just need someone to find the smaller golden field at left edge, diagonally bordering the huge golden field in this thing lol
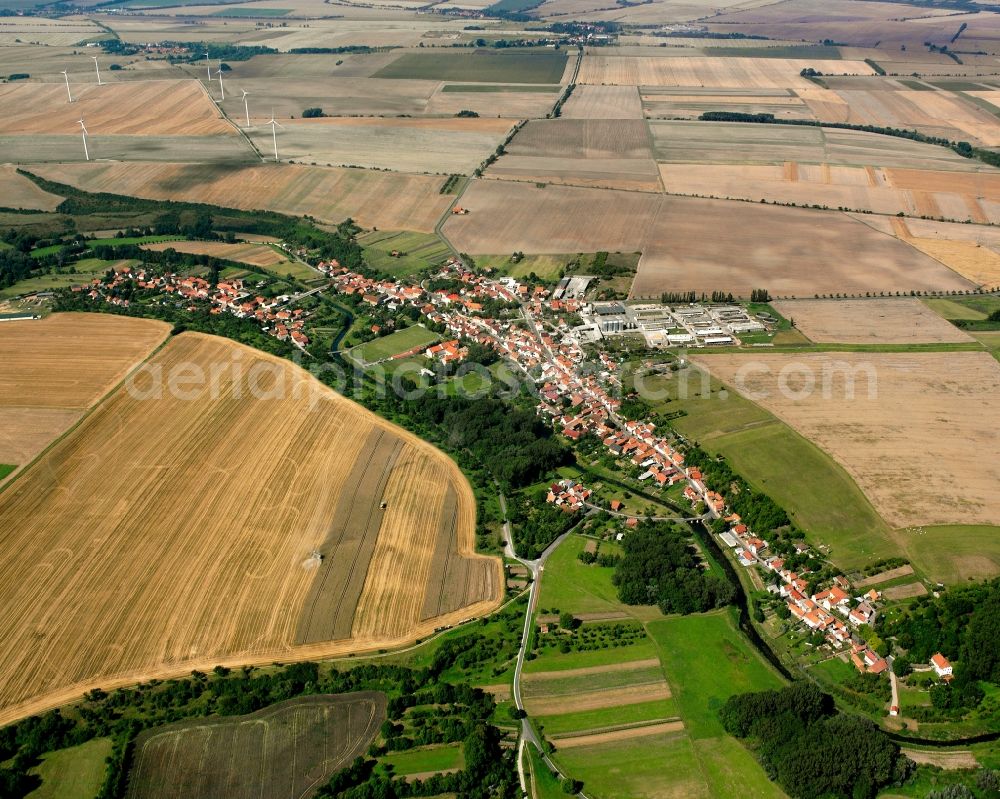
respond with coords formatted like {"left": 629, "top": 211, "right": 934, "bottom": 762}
{"left": 0, "top": 314, "right": 170, "bottom": 480}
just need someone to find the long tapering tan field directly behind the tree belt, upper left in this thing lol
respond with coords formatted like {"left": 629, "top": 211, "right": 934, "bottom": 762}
{"left": 31, "top": 162, "right": 454, "bottom": 231}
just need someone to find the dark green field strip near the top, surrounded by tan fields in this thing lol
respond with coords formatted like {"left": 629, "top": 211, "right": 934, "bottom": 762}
{"left": 372, "top": 49, "right": 566, "bottom": 84}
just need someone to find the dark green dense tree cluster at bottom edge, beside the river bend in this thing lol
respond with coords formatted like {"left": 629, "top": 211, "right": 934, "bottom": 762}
{"left": 719, "top": 682, "right": 913, "bottom": 799}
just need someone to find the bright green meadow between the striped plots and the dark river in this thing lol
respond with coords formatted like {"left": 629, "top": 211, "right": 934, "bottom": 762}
{"left": 646, "top": 610, "right": 782, "bottom": 738}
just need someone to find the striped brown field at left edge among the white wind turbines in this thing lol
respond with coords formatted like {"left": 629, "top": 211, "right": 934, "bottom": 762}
{"left": 0, "top": 80, "right": 237, "bottom": 136}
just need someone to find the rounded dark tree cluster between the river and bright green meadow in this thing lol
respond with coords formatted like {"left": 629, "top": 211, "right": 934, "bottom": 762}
{"left": 612, "top": 521, "right": 736, "bottom": 613}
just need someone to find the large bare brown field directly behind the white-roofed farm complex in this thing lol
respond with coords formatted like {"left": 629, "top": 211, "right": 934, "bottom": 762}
{"left": 632, "top": 197, "right": 973, "bottom": 298}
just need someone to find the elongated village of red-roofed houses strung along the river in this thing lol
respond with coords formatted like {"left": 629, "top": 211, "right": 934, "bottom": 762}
{"left": 75, "top": 253, "right": 951, "bottom": 715}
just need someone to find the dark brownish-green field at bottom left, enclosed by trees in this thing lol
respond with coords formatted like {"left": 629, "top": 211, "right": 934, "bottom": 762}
{"left": 126, "top": 692, "right": 386, "bottom": 799}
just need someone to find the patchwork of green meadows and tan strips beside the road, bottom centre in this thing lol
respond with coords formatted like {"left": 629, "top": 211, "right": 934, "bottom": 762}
{"left": 522, "top": 536, "right": 783, "bottom": 799}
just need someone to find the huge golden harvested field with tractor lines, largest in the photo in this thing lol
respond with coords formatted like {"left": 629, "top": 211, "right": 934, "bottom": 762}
{"left": 0, "top": 333, "right": 502, "bottom": 723}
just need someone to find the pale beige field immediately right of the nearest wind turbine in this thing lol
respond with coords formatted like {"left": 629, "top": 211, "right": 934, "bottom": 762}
{"left": 242, "top": 118, "right": 511, "bottom": 174}
